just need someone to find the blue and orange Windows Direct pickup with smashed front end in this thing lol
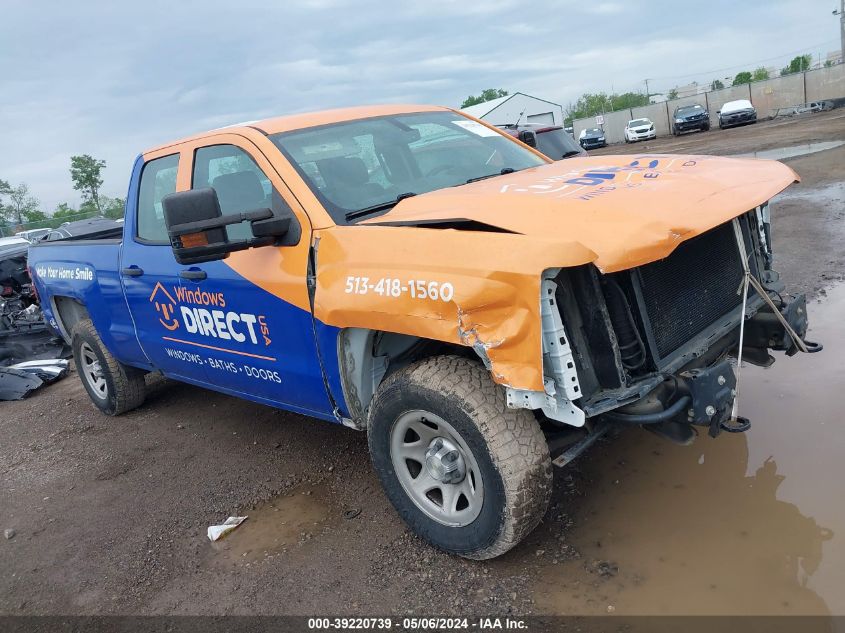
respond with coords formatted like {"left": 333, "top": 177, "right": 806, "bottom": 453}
{"left": 30, "top": 106, "right": 817, "bottom": 559}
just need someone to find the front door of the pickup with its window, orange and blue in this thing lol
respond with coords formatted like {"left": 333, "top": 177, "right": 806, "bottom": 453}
{"left": 179, "top": 135, "right": 333, "bottom": 417}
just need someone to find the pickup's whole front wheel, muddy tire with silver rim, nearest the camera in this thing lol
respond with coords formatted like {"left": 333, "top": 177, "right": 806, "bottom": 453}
{"left": 368, "top": 356, "right": 552, "bottom": 560}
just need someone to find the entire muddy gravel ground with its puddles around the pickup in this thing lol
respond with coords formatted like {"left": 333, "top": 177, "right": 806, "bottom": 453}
{"left": 0, "top": 110, "right": 845, "bottom": 615}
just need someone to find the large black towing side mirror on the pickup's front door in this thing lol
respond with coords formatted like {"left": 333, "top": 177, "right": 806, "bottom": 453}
{"left": 161, "top": 187, "right": 290, "bottom": 264}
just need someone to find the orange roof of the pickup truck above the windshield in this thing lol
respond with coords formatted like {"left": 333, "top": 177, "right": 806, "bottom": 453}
{"left": 143, "top": 104, "right": 451, "bottom": 154}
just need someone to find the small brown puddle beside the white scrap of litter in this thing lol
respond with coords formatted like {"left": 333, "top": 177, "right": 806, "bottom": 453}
{"left": 210, "top": 487, "right": 330, "bottom": 562}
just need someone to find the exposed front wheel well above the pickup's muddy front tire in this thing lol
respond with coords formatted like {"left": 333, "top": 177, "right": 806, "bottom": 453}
{"left": 338, "top": 328, "right": 468, "bottom": 429}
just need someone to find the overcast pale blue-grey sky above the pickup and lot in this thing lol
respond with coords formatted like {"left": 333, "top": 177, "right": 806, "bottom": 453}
{"left": 0, "top": 0, "right": 839, "bottom": 211}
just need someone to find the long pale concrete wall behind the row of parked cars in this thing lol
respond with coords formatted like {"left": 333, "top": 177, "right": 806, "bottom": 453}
{"left": 573, "top": 64, "right": 845, "bottom": 143}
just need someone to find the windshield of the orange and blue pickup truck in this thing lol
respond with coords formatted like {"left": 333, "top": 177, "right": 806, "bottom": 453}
{"left": 270, "top": 112, "right": 545, "bottom": 224}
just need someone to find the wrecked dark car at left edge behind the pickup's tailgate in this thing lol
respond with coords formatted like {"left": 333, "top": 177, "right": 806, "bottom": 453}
{"left": 0, "top": 237, "right": 68, "bottom": 400}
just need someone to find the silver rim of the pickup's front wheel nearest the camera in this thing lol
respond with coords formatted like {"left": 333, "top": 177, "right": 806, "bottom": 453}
{"left": 390, "top": 410, "right": 484, "bottom": 527}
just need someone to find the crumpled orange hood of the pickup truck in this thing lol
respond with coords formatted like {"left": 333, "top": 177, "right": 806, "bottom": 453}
{"left": 363, "top": 154, "right": 799, "bottom": 273}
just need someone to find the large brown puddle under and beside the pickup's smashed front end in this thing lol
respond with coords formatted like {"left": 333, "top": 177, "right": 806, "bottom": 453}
{"left": 535, "top": 286, "right": 845, "bottom": 615}
